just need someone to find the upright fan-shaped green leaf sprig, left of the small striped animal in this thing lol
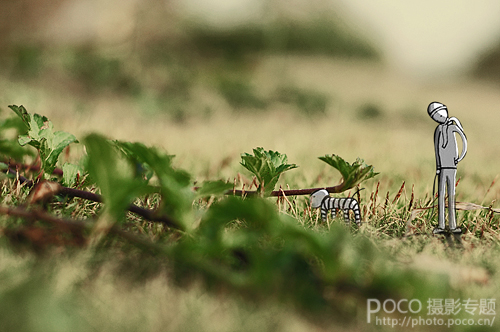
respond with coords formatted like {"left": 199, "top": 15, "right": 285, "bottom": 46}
{"left": 241, "top": 147, "right": 298, "bottom": 196}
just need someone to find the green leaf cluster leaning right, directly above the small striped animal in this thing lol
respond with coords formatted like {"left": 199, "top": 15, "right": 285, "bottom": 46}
{"left": 319, "top": 154, "right": 379, "bottom": 191}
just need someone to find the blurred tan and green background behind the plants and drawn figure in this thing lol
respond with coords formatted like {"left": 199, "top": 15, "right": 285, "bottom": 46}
{"left": 0, "top": 0, "right": 500, "bottom": 198}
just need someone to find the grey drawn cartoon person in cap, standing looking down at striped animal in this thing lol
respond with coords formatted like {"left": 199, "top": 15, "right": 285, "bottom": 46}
{"left": 427, "top": 102, "right": 467, "bottom": 234}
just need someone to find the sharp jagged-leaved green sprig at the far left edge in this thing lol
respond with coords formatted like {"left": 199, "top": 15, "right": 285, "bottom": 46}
{"left": 9, "top": 105, "right": 77, "bottom": 179}
